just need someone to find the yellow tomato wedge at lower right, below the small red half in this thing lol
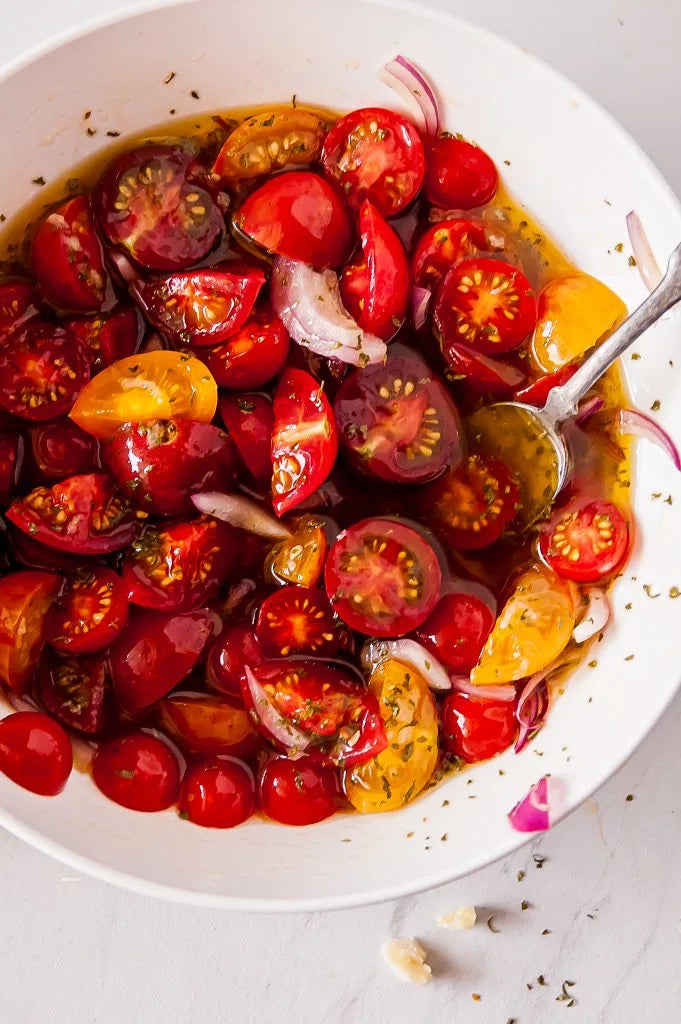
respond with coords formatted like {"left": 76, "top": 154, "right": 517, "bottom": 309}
{"left": 471, "top": 564, "right": 574, "bottom": 686}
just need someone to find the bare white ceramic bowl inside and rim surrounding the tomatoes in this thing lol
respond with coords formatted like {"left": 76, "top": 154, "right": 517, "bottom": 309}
{"left": 0, "top": 0, "right": 681, "bottom": 910}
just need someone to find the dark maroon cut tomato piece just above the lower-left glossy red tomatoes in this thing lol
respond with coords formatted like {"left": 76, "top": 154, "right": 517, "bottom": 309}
{"left": 37, "top": 652, "right": 111, "bottom": 736}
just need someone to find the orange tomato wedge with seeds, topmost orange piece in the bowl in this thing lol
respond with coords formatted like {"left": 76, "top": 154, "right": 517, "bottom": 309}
{"left": 211, "top": 106, "right": 327, "bottom": 181}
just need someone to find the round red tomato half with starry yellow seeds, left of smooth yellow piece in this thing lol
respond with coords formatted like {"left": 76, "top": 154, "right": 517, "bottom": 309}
{"left": 433, "top": 259, "right": 537, "bottom": 355}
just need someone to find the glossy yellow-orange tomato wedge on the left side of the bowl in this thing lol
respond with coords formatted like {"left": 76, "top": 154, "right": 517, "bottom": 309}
{"left": 69, "top": 352, "right": 217, "bottom": 439}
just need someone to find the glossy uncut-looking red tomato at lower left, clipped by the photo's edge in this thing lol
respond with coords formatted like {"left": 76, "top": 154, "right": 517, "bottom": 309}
{"left": 0, "top": 711, "right": 74, "bottom": 797}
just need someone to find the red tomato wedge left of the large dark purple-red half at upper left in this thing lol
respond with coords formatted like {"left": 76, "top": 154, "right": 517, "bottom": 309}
{"left": 31, "top": 196, "right": 109, "bottom": 313}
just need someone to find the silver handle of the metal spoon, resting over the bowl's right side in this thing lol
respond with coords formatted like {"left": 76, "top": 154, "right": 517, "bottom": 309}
{"left": 544, "top": 238, "right": 681, "bottom": 427}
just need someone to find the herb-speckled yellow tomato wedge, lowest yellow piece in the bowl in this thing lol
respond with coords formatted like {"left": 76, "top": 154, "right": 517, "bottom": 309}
{"left": 344, "top": 658, "right": 437, "bottom": 814}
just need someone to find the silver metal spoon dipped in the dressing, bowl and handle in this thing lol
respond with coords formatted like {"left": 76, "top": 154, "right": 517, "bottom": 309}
{"left": 468, "top": 244, "right": 681, "bottom": 526}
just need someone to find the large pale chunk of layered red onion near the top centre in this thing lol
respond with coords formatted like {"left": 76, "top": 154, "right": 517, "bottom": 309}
{"left": 270, "top": 256, "right": 386, "bottom": 367}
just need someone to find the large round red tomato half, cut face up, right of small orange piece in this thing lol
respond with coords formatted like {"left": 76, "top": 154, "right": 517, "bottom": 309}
{"left": 325, "top": 519, "right": 441, "bottom": 637}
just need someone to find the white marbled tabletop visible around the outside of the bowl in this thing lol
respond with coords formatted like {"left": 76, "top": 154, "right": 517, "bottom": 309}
{"left": 0, "top": 0, "right": 681, "bottom": 1024}
